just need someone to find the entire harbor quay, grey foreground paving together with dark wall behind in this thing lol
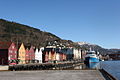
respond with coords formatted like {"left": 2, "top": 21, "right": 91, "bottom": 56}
{"left": 0, "top": 62, "right": 116, "bottom": 80}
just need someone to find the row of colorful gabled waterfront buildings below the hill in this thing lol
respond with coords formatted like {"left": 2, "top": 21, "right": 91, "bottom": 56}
{"left": 0, "top": 42, "right": 86, "bottom": 65}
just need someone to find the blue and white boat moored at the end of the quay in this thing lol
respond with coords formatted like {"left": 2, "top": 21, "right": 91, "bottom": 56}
{"left": 84, "top": 51, "right": 100, "bottom": 64}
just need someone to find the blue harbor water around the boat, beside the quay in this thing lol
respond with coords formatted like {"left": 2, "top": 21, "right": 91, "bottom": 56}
{"left": 74, "top": 61, "right": 120, "bottom": 80}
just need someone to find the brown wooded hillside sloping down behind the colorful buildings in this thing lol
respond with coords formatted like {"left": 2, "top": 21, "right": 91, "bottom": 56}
{"left": 0, "top": 19, "right": 73, "bottom": 47}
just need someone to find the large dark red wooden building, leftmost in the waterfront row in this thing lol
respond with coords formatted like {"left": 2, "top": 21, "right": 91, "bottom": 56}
{"left": 0, "top": 42, "right": 17, "bottom": 65}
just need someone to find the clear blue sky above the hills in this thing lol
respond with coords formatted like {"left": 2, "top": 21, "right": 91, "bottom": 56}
{"left": 0, "top": 0, "right": 120, "bottom": 48}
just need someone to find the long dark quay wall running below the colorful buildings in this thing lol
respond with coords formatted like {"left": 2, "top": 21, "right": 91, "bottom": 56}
{"left": 8, "top": 61, "right": 83, "bottom": 71}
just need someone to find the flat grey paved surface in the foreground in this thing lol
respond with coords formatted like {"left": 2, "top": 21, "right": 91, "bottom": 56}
{"left": 0, "top": 70, "right": 105, "bottom": 80}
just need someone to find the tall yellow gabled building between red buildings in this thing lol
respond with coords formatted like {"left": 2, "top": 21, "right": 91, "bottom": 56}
{"left": 18, "top": 43, "right": 26, "bottom": 64}
